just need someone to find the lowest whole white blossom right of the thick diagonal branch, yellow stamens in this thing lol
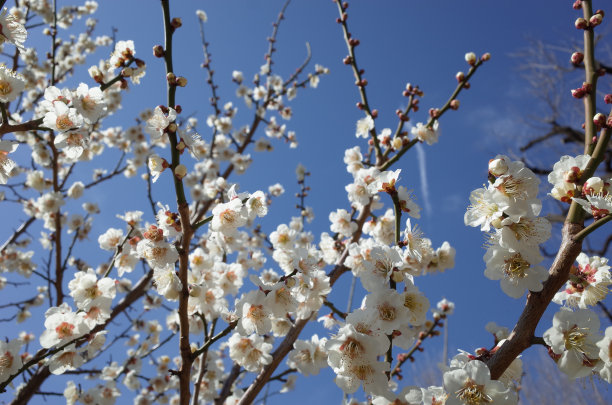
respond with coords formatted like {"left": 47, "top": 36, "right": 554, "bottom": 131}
{"left": 543, "top": 308, "right": 601, "bottom": 378}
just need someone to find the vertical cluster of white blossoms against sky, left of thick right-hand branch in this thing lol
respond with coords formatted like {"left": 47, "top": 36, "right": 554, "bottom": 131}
{"left": 464, "top": 156, "right": 551, "bottom": 298}
